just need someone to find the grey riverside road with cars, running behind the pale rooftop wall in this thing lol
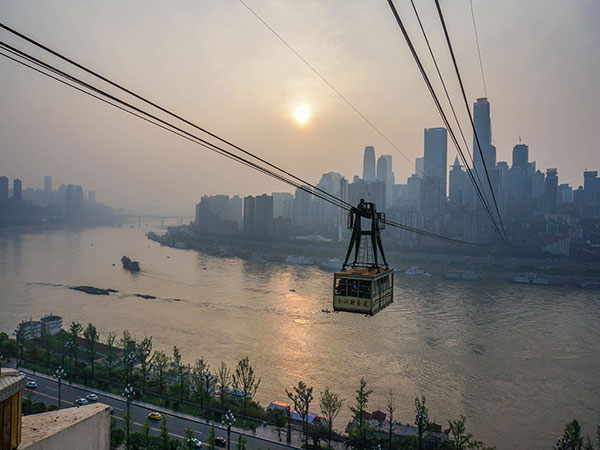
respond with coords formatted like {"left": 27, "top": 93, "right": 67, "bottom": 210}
{"left": 20, "top": 368, "right": 300, "bottom": 450}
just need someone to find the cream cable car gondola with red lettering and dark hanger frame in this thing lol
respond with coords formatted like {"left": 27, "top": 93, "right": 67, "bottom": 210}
{"left": 333, "top": 199, "right": 394, "bottom": 315}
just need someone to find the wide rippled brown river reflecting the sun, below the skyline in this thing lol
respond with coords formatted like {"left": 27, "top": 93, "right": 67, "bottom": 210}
{"left": 0, "top": 228, "right": 600, "bottom": 450}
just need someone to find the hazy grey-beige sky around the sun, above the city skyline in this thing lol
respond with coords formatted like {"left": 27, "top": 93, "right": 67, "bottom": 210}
{"left": 0, "top": 0, "right": 600, "bottom": 213}
